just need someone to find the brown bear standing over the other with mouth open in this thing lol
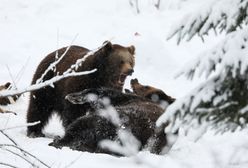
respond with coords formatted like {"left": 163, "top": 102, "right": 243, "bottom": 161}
{"left": 27, "top": 42, "right": 135, "bottom": 137}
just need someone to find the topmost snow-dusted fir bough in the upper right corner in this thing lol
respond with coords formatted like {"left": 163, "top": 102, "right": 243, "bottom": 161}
{"left": 167, "top": 0, "right": 248, "bottom": 44}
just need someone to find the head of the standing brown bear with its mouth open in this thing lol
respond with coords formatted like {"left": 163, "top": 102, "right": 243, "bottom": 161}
{"left": 96, "top": 41, "right": 135, "bottom": 90}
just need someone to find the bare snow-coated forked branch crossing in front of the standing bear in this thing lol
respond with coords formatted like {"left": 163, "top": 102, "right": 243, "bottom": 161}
{"left": 0, "top": 43, "right": 110, "bottom": 97}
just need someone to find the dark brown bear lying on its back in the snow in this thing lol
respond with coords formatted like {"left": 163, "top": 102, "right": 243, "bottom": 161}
{"left": 50, "top": 79, "right": 174, "bottom": 154}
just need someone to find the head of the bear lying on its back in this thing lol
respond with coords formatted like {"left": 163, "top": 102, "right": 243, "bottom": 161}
{"left": 130, "top": 79, "right": 175, "bottom": 104}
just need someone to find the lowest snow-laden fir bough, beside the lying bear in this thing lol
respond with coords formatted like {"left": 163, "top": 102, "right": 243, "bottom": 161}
{"left": 157, "top": 71, "right": 248, "bottom": 133}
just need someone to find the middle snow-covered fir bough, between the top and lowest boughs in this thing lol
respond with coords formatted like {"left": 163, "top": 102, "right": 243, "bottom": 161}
{"left": 177, "top": 26, "right": 248, "bottom": 79}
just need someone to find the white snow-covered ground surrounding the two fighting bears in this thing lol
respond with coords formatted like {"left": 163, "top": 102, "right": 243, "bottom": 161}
{"left": 0, "top": 0, "right": 248, "bottom": 168}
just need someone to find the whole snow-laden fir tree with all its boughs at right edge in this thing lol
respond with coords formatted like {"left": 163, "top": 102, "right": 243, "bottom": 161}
{"left": 157, "top": 0, "right": 248, "bottom": 132}
